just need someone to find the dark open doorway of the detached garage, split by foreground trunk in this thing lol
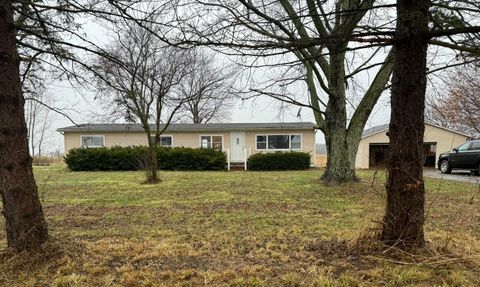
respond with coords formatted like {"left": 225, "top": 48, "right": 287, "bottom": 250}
{"left": 368, "top": 143, "right": 437, "bottom": 168}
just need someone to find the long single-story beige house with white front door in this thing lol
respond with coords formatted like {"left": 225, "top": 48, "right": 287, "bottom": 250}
{"left": 57, "top": 122, "right": 316, "bottom": 168}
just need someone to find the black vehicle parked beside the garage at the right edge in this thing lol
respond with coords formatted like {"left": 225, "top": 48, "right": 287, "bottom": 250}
{"left": 438, "top": 140, "right": 480, "bottom": 175}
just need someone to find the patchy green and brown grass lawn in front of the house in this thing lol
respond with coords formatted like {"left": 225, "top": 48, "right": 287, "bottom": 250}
{"left": 0, "top": 166, "right": 480, "bottom": 287}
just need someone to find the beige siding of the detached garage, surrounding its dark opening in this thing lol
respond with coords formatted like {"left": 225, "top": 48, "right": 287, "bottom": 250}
{"left": 355, "top": 124, "right": 467, "bottom": 168}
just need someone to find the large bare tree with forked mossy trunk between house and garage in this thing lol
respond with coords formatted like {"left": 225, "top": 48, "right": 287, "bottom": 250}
{"left": 167, "top": 0, "right": 392, "bottom": 183}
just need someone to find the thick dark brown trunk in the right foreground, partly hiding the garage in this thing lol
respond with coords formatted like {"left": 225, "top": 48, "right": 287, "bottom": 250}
{"left": 381, "top": 0, "right": 428, "bottom": 247}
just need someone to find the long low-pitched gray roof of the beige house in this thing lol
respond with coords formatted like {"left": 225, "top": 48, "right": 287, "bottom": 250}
{"left": 57, "top": 122, "right": 317, "bottom": 132}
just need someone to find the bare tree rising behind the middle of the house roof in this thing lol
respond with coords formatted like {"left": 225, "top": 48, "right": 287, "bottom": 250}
{"left": 179, "top": 48, "right": 236, "bottom": 124}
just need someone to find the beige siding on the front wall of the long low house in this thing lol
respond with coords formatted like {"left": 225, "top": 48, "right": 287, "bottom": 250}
{"left": 64, "top": 129, "right": 315, "bottom": 164}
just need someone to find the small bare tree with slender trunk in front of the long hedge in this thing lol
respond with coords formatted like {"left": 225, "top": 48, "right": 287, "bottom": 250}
{"left": 96, "top": 21, "right": 190, "bottom": 183}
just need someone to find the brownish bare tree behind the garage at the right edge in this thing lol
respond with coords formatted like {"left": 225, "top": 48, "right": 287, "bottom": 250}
{"left": 425, "top": 64, "right": 480, "bottom": 138}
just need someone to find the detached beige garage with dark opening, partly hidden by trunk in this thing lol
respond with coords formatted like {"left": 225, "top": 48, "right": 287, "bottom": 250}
{"left": 356, "top": 123, "right": 469, "bottom": 168}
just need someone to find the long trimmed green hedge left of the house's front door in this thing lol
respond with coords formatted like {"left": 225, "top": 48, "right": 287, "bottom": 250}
{"left": 64, "top": 146, "right": 227, "bottom": 171}
